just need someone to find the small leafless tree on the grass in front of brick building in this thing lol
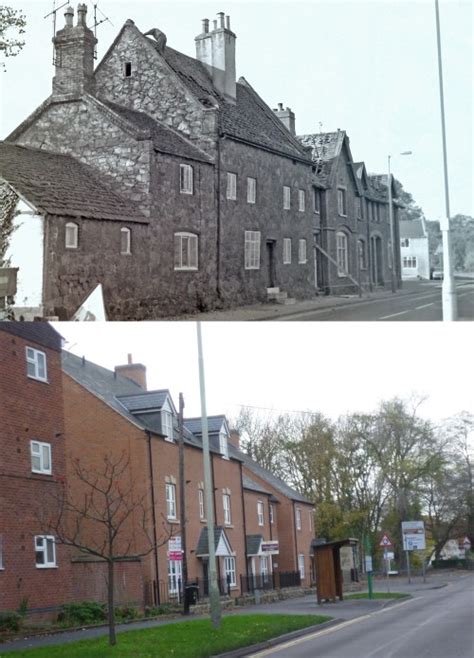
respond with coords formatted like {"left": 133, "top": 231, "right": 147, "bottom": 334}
{"left": 39, "top": 453, "right": 172, "bottom": 645}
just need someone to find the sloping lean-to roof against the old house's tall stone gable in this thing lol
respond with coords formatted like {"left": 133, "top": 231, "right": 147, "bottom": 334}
{"left": 102, "top": 101, "right": 211, "bottom": 162}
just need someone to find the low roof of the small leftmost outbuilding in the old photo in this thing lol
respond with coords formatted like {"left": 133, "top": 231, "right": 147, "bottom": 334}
{"left": 0, "top": 142, "right": 148, "bottom": 223}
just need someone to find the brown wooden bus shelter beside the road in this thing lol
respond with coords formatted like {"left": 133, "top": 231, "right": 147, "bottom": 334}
{"left": 313, "top": 538, "right": 358, "bottom": 603}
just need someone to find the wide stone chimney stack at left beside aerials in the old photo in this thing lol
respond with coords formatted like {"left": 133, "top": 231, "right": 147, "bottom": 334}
{"left": 53, "top": 4, "right": 97, "bottom": 96}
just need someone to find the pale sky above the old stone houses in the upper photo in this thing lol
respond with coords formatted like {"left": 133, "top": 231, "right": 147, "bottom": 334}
{"left": 0, "top": 0, "right": 474, "bottom": 220}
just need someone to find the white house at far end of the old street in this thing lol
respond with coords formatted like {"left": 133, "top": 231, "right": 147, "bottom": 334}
{"left": 400, "top": 218, "right": 430, "bottom": 279}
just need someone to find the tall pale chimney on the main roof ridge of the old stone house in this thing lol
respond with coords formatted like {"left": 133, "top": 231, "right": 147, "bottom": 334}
{"left": 195, "top": 12, "right": 237, "bottom": 102}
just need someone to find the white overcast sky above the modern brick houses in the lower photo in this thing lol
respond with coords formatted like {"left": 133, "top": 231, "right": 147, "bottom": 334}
{"left": 54, "top": 322, "right": 474, "bottom": 421}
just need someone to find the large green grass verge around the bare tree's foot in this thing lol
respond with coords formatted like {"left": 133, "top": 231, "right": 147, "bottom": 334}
{"left": 1, "top": 615, "right": 331, "bottom": 658}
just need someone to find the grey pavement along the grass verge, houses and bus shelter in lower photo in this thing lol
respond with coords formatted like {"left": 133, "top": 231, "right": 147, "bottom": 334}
{"left": 0, "top": 571, "right": 472, "bottom": 657}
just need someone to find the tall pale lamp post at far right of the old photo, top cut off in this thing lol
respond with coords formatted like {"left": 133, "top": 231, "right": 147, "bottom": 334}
{"left": 435, "top": 0, "right": 458, "bottom": 322}
